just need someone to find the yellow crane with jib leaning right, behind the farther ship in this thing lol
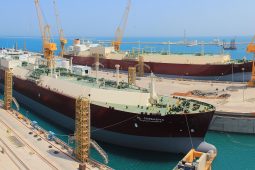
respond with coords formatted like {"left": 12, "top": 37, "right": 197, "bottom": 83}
{"left": 112, "top": 0, "right": 131, "bottom": 51}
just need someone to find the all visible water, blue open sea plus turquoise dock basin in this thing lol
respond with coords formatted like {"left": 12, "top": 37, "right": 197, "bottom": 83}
{"left": 0, "top": 37, "right": 255, "bottom": 170}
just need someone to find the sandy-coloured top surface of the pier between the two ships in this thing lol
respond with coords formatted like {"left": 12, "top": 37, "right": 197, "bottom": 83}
{"left": 92, "top": 71, "right": 255, "bottom": 113}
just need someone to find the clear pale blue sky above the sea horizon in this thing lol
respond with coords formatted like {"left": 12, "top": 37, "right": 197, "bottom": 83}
{"left": 0, "top": 0, "right": 255, "bottom": 37}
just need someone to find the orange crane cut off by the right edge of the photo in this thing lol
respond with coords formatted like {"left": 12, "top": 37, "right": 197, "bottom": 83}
{"left": 246, "top": 36, "right": 255, "bottom": 87}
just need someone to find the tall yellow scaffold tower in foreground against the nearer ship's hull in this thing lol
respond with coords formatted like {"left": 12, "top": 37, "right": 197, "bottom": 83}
{"left": 75, "top": 97, "right": 90, "bottom": 163}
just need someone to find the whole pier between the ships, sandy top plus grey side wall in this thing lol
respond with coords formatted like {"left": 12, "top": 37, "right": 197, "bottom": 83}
{"left": 92, "top": 71, "right": 255, "bottom": 134}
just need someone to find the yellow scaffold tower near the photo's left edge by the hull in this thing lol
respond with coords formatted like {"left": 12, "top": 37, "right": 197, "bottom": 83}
{"left": 4, "top": 69, "right": 12, "bottom": 110}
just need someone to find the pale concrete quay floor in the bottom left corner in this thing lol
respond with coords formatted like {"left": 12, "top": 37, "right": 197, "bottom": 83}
{"left": 0, "top": 105, "right": 112, "bottom": 170}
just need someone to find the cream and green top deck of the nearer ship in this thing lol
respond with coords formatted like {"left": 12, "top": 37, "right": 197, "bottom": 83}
{"left": 11, "top": 66, "right": 214, "bottom": 116}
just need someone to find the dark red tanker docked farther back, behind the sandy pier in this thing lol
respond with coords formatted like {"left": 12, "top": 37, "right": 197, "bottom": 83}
{"left": 64, "top": 39, "right": 252, "bottom": 77}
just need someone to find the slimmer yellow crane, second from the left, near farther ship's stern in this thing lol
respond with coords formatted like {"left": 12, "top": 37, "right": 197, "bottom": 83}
{"left": 53, "top": 0, "right": 67, "bottom": 57}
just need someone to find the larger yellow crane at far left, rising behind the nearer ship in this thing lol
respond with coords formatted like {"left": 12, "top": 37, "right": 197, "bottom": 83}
{"left": 34, "top": 0, "right": 57, "bottom": 68}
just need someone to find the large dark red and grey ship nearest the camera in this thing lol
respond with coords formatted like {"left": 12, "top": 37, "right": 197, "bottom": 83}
{"left": 0, "top": 48, "right": 216, "bottom": 153}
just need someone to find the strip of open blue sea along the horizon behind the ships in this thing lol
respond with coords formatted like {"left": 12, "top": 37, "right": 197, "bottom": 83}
{"left": 0, "top": 36, "right": 252, "bottom": 59}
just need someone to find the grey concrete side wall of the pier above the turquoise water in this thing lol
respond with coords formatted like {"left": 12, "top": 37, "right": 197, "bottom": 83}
{"left": 209, "top": 112, "right": 255, "bottom": 134}
